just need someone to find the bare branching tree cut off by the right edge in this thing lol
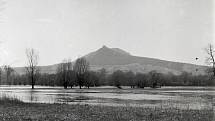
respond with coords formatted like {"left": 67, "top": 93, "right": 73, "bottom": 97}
{"left": 205, "top": 44, "right": 215, "bottom": 76}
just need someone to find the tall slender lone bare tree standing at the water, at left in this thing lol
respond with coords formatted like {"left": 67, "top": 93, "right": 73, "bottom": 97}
{"left": 26, "top": 48, "right": 39, "bottom": 89}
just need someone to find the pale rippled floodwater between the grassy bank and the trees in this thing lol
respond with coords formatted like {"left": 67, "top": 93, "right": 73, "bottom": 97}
{"left": 0, "top": 85, "right": 215, "bottom": 109}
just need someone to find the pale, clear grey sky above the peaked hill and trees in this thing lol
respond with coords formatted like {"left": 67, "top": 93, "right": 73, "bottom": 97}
{"left": 0, "top": 0, "right": 215, "bottom": 66}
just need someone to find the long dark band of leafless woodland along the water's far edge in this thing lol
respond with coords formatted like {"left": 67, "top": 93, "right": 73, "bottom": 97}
{"left": 0, "top": 58, "right": 215, "bottom": 89}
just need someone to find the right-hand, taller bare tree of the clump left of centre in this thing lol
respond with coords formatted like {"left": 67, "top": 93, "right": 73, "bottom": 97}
{"left": 74, "top": 57, "right": 89, "bottom": 89}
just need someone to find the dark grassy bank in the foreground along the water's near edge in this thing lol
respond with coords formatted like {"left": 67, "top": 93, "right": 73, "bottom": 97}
{"left": 0, "top": 98, "right": 214, "bottom": 121}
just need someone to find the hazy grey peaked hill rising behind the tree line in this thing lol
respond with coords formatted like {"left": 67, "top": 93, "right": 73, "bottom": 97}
{"left": 15, "top": 46, "right": 207, "bottom": 75}
